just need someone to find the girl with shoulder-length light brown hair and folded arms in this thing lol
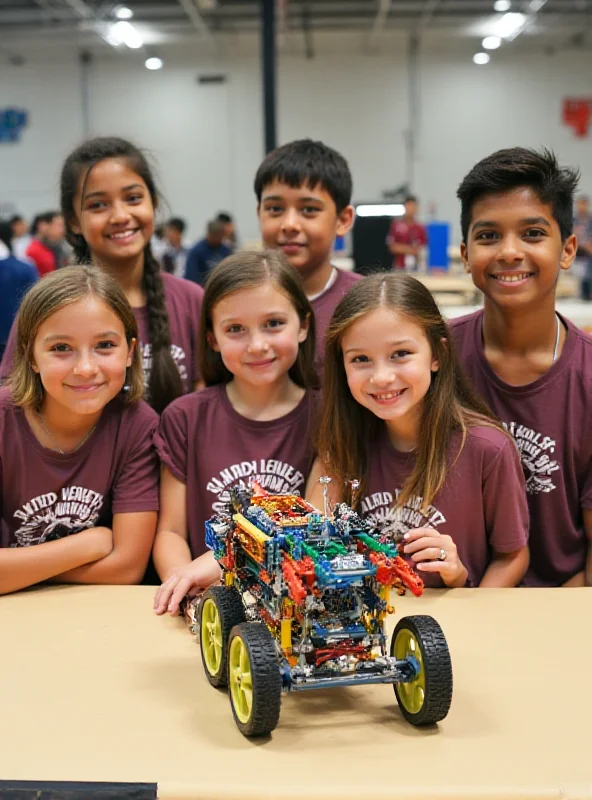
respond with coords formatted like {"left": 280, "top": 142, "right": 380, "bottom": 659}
{"left": 0, "top": 267, "right": 158, "bottom": 594}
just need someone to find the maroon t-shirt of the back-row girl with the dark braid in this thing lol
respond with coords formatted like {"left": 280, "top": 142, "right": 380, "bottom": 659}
{"left": 0, "top": 272, "right": 203, "bottom": 392}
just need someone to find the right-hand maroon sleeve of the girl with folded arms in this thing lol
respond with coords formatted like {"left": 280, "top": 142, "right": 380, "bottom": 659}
{"left": 112, "top": 408, "right": 160, "bottom": 514}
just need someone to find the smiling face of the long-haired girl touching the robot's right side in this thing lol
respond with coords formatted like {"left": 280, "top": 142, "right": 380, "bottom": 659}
{"left": 341, "top": 306, "right": 438, "bottom": 444}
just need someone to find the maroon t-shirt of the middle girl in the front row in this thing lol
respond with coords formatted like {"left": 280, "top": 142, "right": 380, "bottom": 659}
{"left": 155, "top": 384, "right": 318, "bottom": 558}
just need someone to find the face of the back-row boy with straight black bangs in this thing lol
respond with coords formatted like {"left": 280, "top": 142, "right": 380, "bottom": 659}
{"left": 257, "top": 180, "right": 353, "bottom": 277}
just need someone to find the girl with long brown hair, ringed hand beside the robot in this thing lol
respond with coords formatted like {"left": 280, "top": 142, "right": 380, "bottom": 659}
{"left": 307, "top": 274, "right": 528, "bottom": 587}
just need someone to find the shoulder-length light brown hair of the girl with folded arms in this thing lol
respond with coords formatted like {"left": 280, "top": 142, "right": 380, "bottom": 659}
{"left": 9, "top": 267, "right": 144, "bottom": 410}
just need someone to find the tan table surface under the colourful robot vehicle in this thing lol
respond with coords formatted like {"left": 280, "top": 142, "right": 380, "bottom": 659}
{"left": 0, "top": 586, "right": 592, "bottom": 800}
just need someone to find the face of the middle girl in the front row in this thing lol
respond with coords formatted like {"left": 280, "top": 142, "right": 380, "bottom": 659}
{"left": 210, "top": 282, "right": 308, "bottom": 386}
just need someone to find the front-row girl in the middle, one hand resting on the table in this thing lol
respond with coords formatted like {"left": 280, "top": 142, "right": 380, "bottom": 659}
{"left": 153, "top": 251, "right": 318, "bottom": 614}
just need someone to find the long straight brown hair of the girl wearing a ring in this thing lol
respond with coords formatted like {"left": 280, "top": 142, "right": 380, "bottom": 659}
{"left": 318, "top": 274, "right": 503, "bottom": 509}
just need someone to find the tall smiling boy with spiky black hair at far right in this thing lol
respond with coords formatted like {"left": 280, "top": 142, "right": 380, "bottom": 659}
{"left": 451, "top": 148, "right": 592, "bottom": 586}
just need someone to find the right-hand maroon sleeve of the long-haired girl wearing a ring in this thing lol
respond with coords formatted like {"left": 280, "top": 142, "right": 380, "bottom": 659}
{"left": 483, "top": 437, "right": 529, "bottom": 553}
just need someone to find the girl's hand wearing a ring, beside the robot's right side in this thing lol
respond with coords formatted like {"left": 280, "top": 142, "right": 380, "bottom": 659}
{"left": 403, "top": 528, "right": 468, "bottom": 586}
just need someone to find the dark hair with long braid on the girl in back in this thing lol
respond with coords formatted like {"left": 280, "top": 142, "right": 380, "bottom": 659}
{"left": 60, "top": 136, "right": 183, "bottom": 414}
